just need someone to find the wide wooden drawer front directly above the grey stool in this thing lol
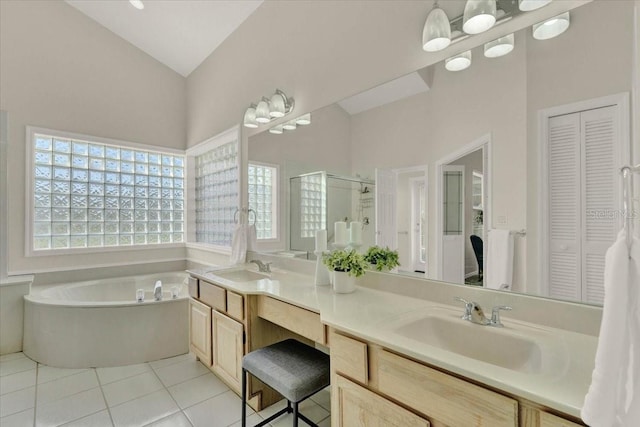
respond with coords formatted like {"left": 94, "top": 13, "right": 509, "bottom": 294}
{"left": 258, "top": 295, "right": 326, "bottom": 344}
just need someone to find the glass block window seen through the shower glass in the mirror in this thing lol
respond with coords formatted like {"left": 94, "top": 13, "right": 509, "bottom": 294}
{"left": 300, "top": 173, "right": 327, "bottom": 237}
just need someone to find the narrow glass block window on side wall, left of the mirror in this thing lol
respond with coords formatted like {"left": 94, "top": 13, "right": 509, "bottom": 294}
{"left": 195, "top": 141, "right": 239, "bottom": 246}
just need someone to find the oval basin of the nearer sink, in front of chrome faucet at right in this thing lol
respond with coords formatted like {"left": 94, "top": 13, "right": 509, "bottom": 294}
{"left": 395, "top": 315, "right": 542, "bottom": 373}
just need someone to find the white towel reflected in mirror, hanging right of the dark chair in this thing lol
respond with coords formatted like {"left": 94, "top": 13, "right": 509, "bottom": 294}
{"left": 484, "top": 229, "right": 513, "bottom": 289}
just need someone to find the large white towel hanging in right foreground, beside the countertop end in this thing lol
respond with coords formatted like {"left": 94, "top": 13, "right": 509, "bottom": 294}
{"left": 581, "top": 231, "right": 640, "bottom": 427}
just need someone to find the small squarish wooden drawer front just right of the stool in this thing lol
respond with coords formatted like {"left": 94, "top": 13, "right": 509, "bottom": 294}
{"left": 330, "top": 331, "right": 369, "bottom": 384}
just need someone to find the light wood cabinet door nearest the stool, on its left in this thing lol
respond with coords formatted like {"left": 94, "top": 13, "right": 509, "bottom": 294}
{"left": 212, "top": 311, "right": 244, "bottom": 393}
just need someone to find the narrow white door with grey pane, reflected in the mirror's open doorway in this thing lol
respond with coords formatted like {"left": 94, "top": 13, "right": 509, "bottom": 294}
{"left": 441, "top": 165, "right": 464, "bottom": 283}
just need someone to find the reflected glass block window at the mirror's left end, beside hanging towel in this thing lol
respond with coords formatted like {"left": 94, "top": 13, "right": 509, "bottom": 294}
{"left": 248, "top": 163, "right": 278, "bottom": 240}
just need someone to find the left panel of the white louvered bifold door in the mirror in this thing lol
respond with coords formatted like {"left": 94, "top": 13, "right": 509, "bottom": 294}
{"left": 547, "top": 113, "right": 582, "bottom": 300}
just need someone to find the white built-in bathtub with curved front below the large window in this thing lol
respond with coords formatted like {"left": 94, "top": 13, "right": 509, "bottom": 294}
{"left": 23, "top": 272, "right": 189, "bottom": 368}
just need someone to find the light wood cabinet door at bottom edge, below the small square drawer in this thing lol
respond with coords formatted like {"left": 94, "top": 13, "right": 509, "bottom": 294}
{"left": 331, "top": 375, "right": 430, "bottom": 427}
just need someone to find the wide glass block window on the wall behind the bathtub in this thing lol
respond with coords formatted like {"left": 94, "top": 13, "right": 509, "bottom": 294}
{"left": 32, "top": 133, "right": 185, "bottom": 251}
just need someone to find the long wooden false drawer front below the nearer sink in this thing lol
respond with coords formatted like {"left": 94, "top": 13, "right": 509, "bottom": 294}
{"left": 377, "top": 350, "right": 518, "bottom": 427}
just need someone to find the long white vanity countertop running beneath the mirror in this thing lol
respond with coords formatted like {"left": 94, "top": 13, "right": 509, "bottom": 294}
{"left": 189, "top": 267, "right": 597, "bottom": 418}
